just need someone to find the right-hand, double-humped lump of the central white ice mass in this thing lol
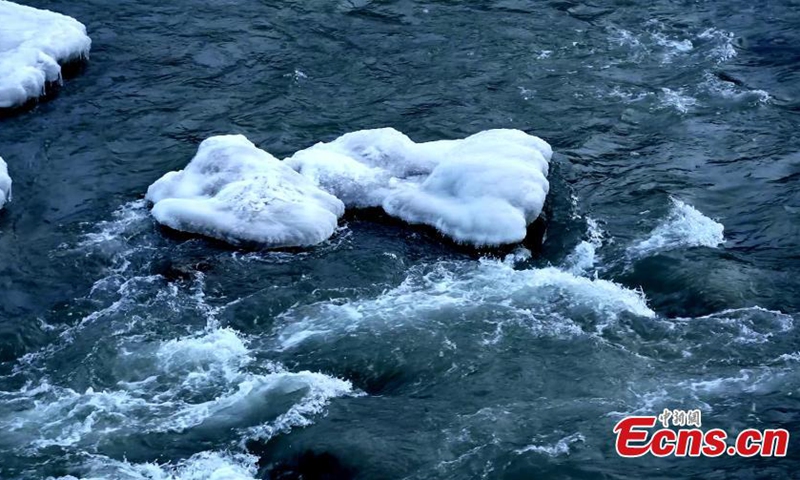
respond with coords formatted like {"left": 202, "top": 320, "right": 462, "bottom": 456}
{"left": 286, "top": 128, "right": 552, "bottom": 246}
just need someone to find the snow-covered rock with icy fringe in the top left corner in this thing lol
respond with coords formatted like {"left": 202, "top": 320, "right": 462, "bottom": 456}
{"left": 0, "top": 0, "right": 92, "bottom": 108}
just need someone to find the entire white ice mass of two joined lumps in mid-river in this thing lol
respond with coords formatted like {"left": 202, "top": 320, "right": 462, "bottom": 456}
{"left": 147, "top": 128, "right": 552, "bottom": 247}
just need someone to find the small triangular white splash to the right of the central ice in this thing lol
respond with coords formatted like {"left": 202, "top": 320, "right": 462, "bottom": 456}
{"left": 628, "top": 198, "right": 725, "bottom": 258}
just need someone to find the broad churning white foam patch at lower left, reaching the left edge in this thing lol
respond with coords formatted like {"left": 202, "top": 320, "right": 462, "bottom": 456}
{"left": 0, "top": 328, "right": 353, "bottom": 451}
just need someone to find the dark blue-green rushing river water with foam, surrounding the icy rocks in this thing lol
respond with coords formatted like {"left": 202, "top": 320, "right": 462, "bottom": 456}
{"left": 0, "top": 0, "right": 800, "bottom": 479}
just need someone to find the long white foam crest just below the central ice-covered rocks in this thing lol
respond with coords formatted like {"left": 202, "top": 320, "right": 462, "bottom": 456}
{"left": 277, "top": 255, "right": 655, "bottom": 349}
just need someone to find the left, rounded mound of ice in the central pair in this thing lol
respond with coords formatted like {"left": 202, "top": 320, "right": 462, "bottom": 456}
{"left": 146, "top": 135, "right": 344, "bottom": 247}
